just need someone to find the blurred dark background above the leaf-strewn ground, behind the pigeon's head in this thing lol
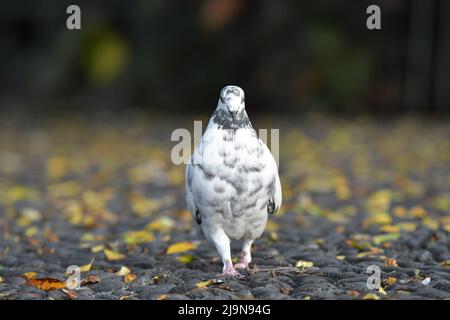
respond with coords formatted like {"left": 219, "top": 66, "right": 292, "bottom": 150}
{"left": 0, "top": 0, "right": 450, "bottom": 115}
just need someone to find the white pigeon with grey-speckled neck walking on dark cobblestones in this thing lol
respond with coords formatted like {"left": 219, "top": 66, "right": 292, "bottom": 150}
{"left": 186, "top": 86, "right": 281, "bottom": 277}
